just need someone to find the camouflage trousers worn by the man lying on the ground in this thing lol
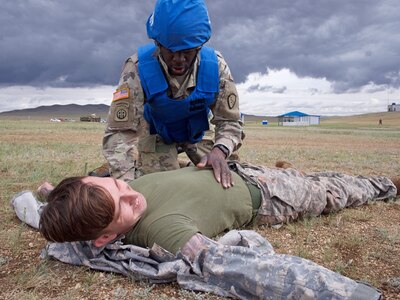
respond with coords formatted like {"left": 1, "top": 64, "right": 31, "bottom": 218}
{"left": 230, "top": 163, "right": 397, "bottom": 225}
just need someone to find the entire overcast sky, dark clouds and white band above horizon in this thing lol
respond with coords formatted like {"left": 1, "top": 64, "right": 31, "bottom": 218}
{"left": 0, "top": 0, "right": 400, "bottom": 115}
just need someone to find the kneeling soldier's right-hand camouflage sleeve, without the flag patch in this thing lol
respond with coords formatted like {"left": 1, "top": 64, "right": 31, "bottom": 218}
{"left": 211, "top": 52, "right": 243, "bottom": 156}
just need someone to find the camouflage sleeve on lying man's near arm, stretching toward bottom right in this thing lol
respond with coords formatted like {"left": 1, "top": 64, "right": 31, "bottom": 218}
{"left": 179, "top": 233, "right": 381, "bottom": 300}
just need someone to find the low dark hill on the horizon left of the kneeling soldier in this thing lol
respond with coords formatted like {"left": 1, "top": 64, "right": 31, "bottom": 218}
{"left": 0, "top": 104, "right": 110, "bottom": 120}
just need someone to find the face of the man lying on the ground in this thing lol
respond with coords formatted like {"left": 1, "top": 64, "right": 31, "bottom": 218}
{"left": 82, "top": 176, "right": 147, "bottom": 239}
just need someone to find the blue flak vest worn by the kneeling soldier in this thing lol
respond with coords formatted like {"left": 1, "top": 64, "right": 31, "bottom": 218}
{"left": 138, "top": 44, "right": 219, "bottom": 144}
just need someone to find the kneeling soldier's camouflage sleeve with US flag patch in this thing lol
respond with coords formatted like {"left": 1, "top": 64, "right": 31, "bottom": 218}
{"left": 103, "top": 55, "right": 148, "bottom": 181}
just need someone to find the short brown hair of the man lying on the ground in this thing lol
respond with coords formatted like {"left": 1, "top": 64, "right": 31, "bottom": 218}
{"left": 39, "top": 177, "right": 115, "bottom": 242}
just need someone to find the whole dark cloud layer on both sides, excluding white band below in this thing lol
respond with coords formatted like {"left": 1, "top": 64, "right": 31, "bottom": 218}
{"left": 0, "top": 0, "right": 400, "bottom": 92}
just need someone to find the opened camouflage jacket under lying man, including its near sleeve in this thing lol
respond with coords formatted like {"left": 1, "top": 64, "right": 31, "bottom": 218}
{"left": 41, "top": 230, "right": 381, "bottom": 300}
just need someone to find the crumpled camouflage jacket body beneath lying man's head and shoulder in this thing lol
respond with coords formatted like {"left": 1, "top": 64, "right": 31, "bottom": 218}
{"left": 41, "top": 236, "right": 186, "bottom": 283}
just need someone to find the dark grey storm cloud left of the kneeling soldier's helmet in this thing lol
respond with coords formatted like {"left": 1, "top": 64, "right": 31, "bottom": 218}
{"left": 0, "top": 0, "right": 154, "bottom": 86}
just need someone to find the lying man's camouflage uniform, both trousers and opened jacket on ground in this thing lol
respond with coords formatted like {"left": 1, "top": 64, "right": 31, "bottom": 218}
{"left": 12, "top": 168, "right": 397, "bottom": 299}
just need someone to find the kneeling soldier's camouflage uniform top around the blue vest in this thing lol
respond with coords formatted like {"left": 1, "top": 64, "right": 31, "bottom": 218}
{"left": 103, "top": 49, "right": 243, "bottom": 181}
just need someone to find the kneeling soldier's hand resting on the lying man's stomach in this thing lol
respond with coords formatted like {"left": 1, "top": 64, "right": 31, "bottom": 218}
{"left": 196, "top": 148, "right": 234, "bottom": 189}
